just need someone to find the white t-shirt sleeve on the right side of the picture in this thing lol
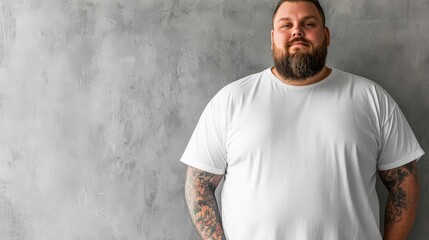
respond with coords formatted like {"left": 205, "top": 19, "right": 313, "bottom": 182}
{"left": 378, "top": 103, "right": 424, "bottom": 170}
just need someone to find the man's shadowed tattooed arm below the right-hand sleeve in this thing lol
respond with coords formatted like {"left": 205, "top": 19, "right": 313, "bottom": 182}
{"left": 378, "top": 161, "right": 420, "bottom": 240}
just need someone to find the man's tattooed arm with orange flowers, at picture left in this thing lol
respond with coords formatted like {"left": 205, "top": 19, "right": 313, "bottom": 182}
{"left": 185, "top": 167, "right": 224, "bottom": 240}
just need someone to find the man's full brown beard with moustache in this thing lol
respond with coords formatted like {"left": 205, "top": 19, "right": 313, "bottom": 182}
{"left": 273, "top": 39, "right": 328, "bottom": 81}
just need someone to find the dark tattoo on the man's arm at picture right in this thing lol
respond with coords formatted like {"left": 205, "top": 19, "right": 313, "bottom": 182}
{"left": 379, "top": 161, "right": 417, "bottom": 228}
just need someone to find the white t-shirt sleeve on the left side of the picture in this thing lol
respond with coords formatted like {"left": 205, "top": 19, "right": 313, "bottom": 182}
{"left": 180, "top": 90, "right": 227, "bottom": 174}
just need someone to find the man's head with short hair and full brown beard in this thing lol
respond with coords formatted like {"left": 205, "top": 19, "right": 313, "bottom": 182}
{"left": 271, "top": 1, "right": 329, "bottom": 81}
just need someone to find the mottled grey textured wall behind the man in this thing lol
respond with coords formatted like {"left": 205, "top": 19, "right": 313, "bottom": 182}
{"left": 0, "top": 0, "right": 429, "bottom": 240}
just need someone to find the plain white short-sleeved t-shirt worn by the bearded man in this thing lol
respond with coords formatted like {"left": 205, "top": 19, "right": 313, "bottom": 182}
{"left": 181, "top": 69, "right": 424, "bottom": 240}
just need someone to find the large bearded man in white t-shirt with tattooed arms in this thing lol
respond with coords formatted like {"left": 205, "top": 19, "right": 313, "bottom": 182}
{"left": 181, "top": 0, "right": 424, "bottom": 240}
